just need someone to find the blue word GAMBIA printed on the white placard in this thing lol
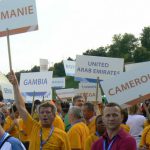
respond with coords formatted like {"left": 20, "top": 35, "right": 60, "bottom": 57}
{"left": 23, "top": 79, "right": 47, "bottom": 85}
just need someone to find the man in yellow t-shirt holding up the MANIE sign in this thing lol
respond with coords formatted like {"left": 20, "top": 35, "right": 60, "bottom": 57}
{"left": 9, "top": 71, "right": 70, "bottom": 150}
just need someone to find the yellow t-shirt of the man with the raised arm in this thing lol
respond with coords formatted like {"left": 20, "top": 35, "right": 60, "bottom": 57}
{"left": 24, "top": 114, "right": 70, "bottom": 150}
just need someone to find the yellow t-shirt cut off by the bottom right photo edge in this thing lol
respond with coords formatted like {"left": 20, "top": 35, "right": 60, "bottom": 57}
{"left": 139, "top": 125, "right": 150, "bottom": 149}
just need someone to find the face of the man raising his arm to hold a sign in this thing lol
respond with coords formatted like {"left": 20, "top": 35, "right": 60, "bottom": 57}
{"left": 39, "top": 107, "right": 55, "bottom": 127}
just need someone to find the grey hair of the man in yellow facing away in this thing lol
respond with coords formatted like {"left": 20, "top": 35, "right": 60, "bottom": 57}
{"left": 68, "top": 106, "right": 83, "bottom": 119}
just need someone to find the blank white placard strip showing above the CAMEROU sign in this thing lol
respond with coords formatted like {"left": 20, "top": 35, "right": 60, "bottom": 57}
{"left": 125, "top": 61, "right": 150, "bottom": 71}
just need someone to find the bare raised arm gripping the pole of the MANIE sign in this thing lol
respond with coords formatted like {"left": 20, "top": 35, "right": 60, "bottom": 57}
{"left": 8, "top": 71, "right": 28, "bottom": 120}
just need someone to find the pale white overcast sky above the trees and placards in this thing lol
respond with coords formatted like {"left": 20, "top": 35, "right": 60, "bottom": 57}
{"left": 0, "top": 0, "right": 150, "bottom": 73}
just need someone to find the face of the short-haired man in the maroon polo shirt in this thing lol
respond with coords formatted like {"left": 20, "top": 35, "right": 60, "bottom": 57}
{"left": 102, "top": 106, "right": 123, "bottom": 130}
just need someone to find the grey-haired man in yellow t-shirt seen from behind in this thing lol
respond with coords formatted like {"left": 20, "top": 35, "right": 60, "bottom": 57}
{"left": 67, "top": 106, "right": 89, "bottom": 150}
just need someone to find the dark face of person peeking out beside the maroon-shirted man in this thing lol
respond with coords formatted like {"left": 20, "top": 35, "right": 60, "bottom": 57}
{"left": 96, "top": 117, "right": 106, "bottom": 134}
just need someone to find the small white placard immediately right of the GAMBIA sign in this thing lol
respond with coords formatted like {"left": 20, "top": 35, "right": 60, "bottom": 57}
{"left": 52, "top": 77, "right": 65, "bottom": 88}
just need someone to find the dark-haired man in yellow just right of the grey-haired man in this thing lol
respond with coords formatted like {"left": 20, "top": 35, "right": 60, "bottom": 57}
{"left": 82, "top": 102, "right": 96, "bottom": 134}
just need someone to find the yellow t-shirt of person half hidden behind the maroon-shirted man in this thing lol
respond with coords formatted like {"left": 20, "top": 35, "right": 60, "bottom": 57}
{"left": 85, "top": 134, "right": 99, "bottom": 150}
